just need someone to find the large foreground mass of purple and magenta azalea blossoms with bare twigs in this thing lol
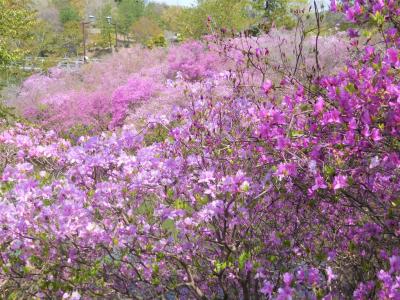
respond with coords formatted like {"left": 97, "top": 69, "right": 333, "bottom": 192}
{"left": 0, "top": 1, "right": 400, "bottom": 299}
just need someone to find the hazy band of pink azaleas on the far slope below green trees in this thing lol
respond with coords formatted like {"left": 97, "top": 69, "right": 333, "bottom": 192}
{"left": 11, "top": 29, "right": 349, "bottom": 136}
